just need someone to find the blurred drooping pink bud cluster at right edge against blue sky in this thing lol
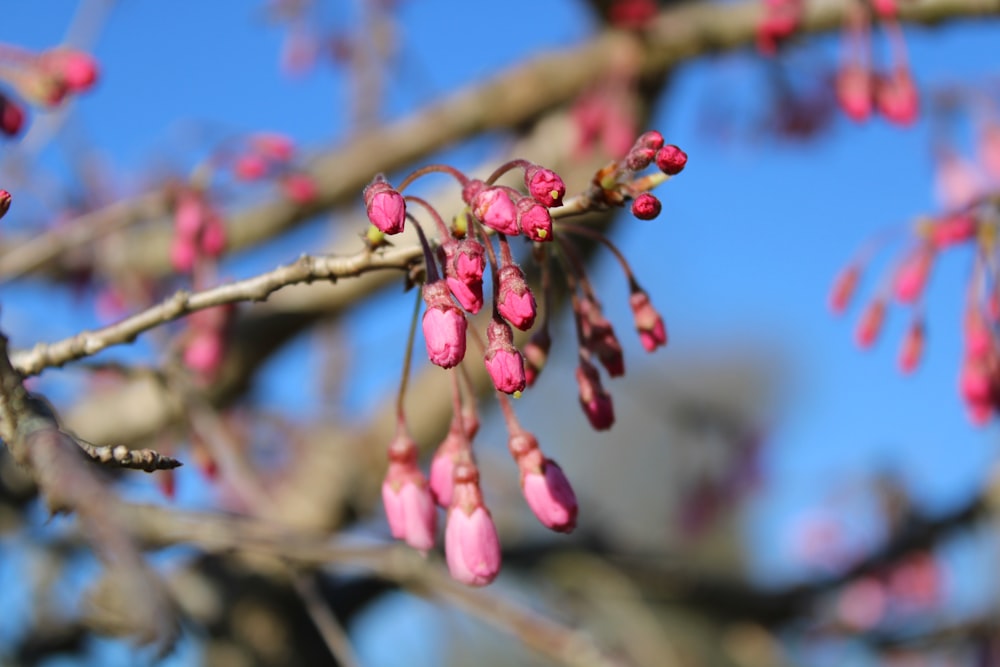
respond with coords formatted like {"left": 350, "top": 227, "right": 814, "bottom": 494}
{"left": 830, "top": 200, "right": 1000, "bottom": 424}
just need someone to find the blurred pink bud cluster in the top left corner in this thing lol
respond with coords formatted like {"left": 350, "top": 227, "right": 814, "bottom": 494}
{"left": 0, "top": 44, "right": 98, "bottom": 136}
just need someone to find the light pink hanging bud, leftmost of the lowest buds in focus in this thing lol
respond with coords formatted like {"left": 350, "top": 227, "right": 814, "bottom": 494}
{"left": 382, "top": 430, "right": 437, "bottom": 552}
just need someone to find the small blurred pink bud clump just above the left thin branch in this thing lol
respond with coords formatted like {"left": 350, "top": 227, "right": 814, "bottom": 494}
{"left": 170, "top": 187, "right": 226, "bottom": 273}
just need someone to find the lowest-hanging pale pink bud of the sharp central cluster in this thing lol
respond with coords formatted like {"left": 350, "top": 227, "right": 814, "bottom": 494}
{"left": 444, "top": 463, "right": 500, "bottom": 586}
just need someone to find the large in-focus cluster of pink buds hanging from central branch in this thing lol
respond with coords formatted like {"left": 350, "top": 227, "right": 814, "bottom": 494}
{"left": 364, "top": 132, "right": 687, "bottom": 585}
